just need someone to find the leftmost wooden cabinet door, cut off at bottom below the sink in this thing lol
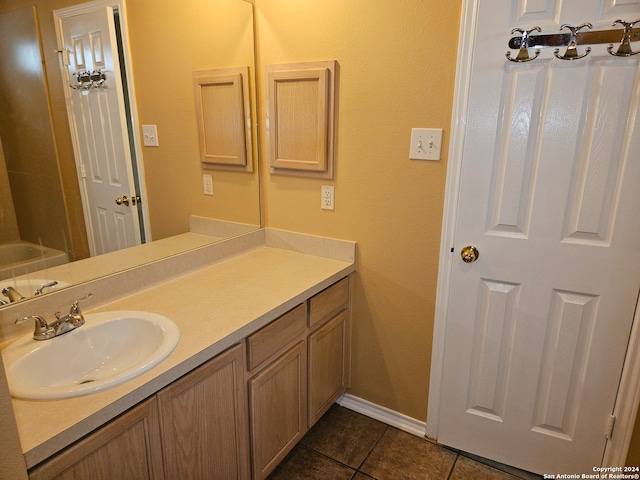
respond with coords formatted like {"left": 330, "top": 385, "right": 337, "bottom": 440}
{"left": 29, "top": 397, "right": 164, "bottom": 480}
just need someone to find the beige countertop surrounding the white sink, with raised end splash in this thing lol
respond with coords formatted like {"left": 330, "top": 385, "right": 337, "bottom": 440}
{"left": 1, "top": 230, "right": 355, "bottom": 467}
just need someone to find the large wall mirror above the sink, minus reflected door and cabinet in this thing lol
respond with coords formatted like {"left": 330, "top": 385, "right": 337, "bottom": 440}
{"left": 0, "top": 0, "right": 261, "bottom": 308}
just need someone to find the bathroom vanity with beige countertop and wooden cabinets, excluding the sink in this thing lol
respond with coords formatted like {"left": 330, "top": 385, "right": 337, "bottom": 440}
{"left": 0, "top": 229, "right": 355, "bottom": 479}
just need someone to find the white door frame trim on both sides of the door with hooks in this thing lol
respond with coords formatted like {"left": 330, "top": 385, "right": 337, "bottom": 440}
{"left": 425, "top": 0, "right": 640, "bottom": 467}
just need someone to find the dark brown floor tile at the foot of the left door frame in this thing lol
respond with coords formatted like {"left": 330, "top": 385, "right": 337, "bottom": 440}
{"left": 360, "top": 428, "right": 457, "bottom": 480}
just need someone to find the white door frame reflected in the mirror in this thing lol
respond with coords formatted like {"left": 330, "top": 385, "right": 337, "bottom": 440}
{"left": 53, "top": 0, "right": 152, "bottom": 249}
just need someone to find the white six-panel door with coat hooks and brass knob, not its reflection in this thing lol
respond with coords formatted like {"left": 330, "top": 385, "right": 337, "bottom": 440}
{"left": 438, "top": 0, "right": 640, "bottom": 474}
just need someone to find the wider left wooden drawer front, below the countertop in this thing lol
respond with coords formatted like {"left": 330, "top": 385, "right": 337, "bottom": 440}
{"left": 247, "top": 303, "right": 307, "bottom": 370}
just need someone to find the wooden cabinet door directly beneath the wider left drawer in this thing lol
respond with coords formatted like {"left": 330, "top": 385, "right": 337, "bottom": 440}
{"left": 249, "top": 341, "right": 307, "bottom": 480}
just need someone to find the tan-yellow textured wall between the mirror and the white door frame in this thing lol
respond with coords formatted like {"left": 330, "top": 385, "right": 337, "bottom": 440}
{"left": 255, "top": 0, "right": 461, "bottom": 420}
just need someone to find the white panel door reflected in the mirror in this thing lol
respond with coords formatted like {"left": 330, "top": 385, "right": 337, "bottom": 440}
{"left": 61, "top": 7, "right": 141, "bottom": 255}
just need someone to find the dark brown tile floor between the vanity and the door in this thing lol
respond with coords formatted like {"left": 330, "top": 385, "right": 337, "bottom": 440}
{"left": 268, "top": 404, "right": 541, "bottom": 480}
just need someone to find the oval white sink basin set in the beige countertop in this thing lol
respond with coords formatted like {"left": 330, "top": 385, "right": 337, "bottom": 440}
{"left": 2, "top": 311, "right": 180, "bottom": 400}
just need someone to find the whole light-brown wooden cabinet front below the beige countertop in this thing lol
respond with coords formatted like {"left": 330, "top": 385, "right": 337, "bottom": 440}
{"left": 29, "top": 277, "right": 350, "bottom": 480}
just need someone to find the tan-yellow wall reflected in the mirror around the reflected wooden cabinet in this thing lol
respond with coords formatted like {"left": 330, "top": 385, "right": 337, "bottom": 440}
{"left": 127, "top": 0, "right": 260, "bottom": 239}
